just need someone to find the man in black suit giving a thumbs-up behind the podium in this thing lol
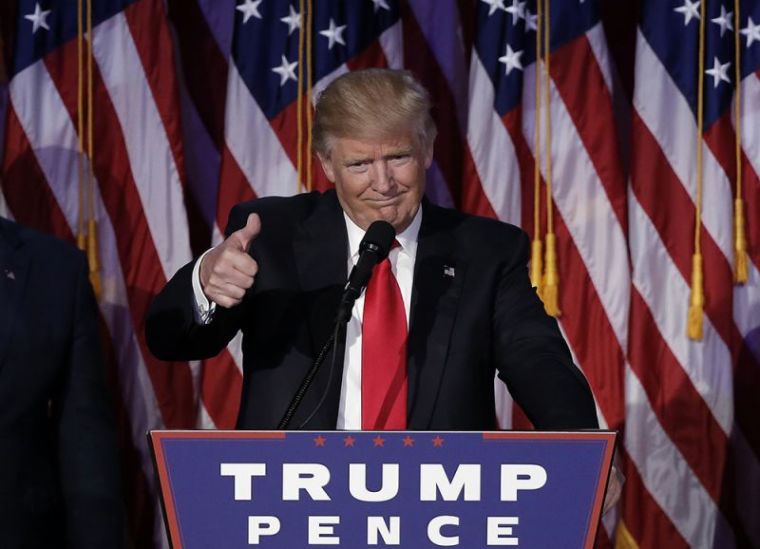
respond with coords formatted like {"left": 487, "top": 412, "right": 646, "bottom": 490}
{"left": 147, "top": 69, "right": 597, "bottom": 430}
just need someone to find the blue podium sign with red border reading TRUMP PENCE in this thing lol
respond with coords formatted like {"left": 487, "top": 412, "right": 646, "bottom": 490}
{"left": 149, "top": 431, "right": 615, "bottom": 549}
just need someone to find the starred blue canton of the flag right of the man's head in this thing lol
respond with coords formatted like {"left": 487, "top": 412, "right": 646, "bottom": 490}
{"left": 475, "top": 0, "right": 599, "bottom": 116}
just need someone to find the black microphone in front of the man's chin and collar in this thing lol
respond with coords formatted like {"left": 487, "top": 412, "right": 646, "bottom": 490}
{"left": 336, "top": 221, "right": 396, "bottom": 324}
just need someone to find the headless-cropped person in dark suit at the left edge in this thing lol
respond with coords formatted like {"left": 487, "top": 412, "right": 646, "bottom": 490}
{"left": 0, "top": 218, "right": 123, "bottom": 549}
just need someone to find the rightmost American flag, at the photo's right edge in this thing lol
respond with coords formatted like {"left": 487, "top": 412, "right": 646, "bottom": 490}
{"left": 623, "top": 0, "right": 760, "bottom": 547}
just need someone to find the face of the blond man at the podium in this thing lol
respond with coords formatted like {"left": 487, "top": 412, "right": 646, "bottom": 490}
{"left": 319, "top": 135, "right": 433, "bottom": 233}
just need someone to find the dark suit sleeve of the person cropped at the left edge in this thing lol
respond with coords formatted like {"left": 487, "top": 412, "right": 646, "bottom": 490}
{"left": 53, "top": 252, "right": 124, "bottom": 549}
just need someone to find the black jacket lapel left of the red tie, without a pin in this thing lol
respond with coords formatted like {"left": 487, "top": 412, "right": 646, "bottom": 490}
{"left": 293, "top": 192, "right": 348, "bottom": 428}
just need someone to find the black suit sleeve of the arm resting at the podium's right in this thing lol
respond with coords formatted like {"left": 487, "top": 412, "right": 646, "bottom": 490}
{"left": 494, "top": 231, "right": 598, "bottom": 429}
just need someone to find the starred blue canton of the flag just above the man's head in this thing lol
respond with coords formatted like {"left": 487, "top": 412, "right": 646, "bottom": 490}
{"left": 232, "top": 0, "right": 400, "bottom": 120}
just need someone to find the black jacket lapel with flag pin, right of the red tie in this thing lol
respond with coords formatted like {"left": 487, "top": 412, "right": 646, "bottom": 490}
{"left": 407, "top": 201, "right": 466, "bottom": 429}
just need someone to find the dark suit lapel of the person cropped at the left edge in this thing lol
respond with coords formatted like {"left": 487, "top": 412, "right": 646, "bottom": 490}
{"left": 0, "top": 220, "right": 30, "bottom": 373}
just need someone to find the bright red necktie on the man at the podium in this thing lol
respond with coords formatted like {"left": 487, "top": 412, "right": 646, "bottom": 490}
{"left": 362, "top": 244, "right": 407, "bottom": 430}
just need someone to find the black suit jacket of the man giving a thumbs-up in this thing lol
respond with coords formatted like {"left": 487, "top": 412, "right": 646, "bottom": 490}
{"left": 147, "top": 191, "right": 597, "bottom": 430}
